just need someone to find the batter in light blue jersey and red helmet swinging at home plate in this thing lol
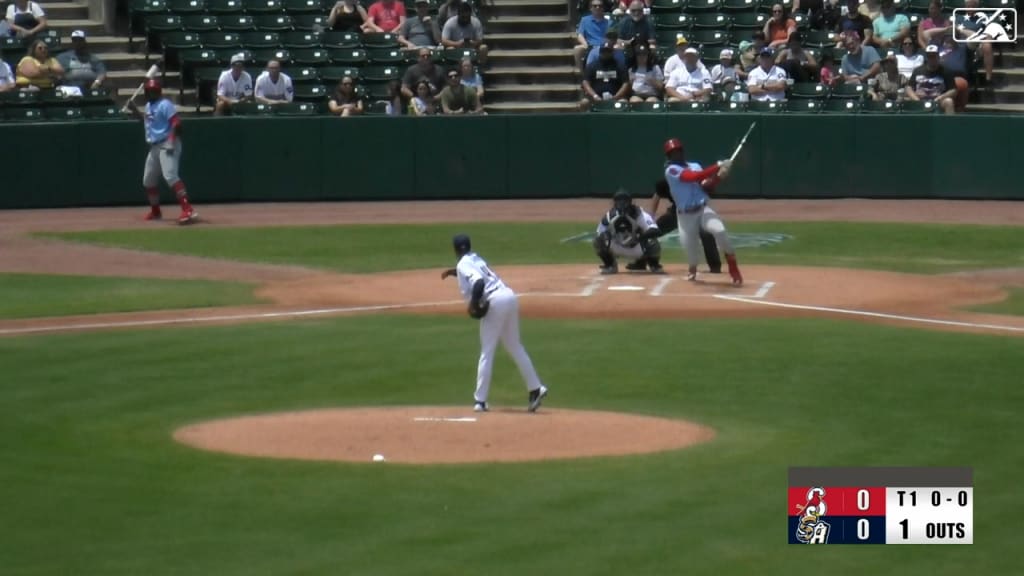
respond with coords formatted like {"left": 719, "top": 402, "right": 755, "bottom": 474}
{"left": 665, "top": 138, "right": 743, "bottom": 286}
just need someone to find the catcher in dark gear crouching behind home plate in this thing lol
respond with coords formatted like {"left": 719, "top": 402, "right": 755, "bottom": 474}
{"left": 594, "top": 190, "right": 665, "bottom": 274}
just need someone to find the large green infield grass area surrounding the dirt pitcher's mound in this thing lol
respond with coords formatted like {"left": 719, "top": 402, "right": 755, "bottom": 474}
{"left": 0, "top": 316, "right": 1024, "bottom": 576}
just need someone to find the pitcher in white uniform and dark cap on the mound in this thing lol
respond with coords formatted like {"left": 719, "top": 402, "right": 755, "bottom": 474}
{"left": 441, "top": 234, "right": 548, "bottom": 412}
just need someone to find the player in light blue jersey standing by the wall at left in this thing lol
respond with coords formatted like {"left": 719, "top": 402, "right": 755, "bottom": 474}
{"left": 128, "top": 78, "right": 199, "bottom": 224}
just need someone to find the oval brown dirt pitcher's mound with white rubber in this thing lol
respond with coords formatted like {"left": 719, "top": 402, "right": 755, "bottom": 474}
{"left": 174, "top": 406, "right": 715, "bottom": 464}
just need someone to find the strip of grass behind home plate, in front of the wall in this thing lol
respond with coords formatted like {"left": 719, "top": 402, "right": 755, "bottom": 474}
{"left": 47, "top": 219, "right": 1024, "bottom": 274}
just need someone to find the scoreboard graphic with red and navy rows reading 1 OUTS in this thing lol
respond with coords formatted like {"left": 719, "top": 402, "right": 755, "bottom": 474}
{"left": 786, "top": 467, "right": 974, "bottom": 544}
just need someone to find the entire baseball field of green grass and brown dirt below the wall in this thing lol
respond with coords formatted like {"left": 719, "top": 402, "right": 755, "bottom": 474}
{"left": 0, "top": 199, "right": 1024, "bottom": 576}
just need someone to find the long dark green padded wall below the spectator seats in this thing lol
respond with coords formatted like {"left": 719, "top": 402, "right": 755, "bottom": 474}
{"left": 0, "top": 114, "right": 1024, "bottom": 208}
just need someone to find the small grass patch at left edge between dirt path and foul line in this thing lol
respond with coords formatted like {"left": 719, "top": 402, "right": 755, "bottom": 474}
{"left": 0, "top": 274, "right": 258, "bottom": 320}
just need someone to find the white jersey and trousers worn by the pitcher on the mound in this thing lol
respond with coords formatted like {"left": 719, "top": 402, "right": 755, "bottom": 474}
{"left": 456, "top": 252, "right": 542, "bottom": 403}
